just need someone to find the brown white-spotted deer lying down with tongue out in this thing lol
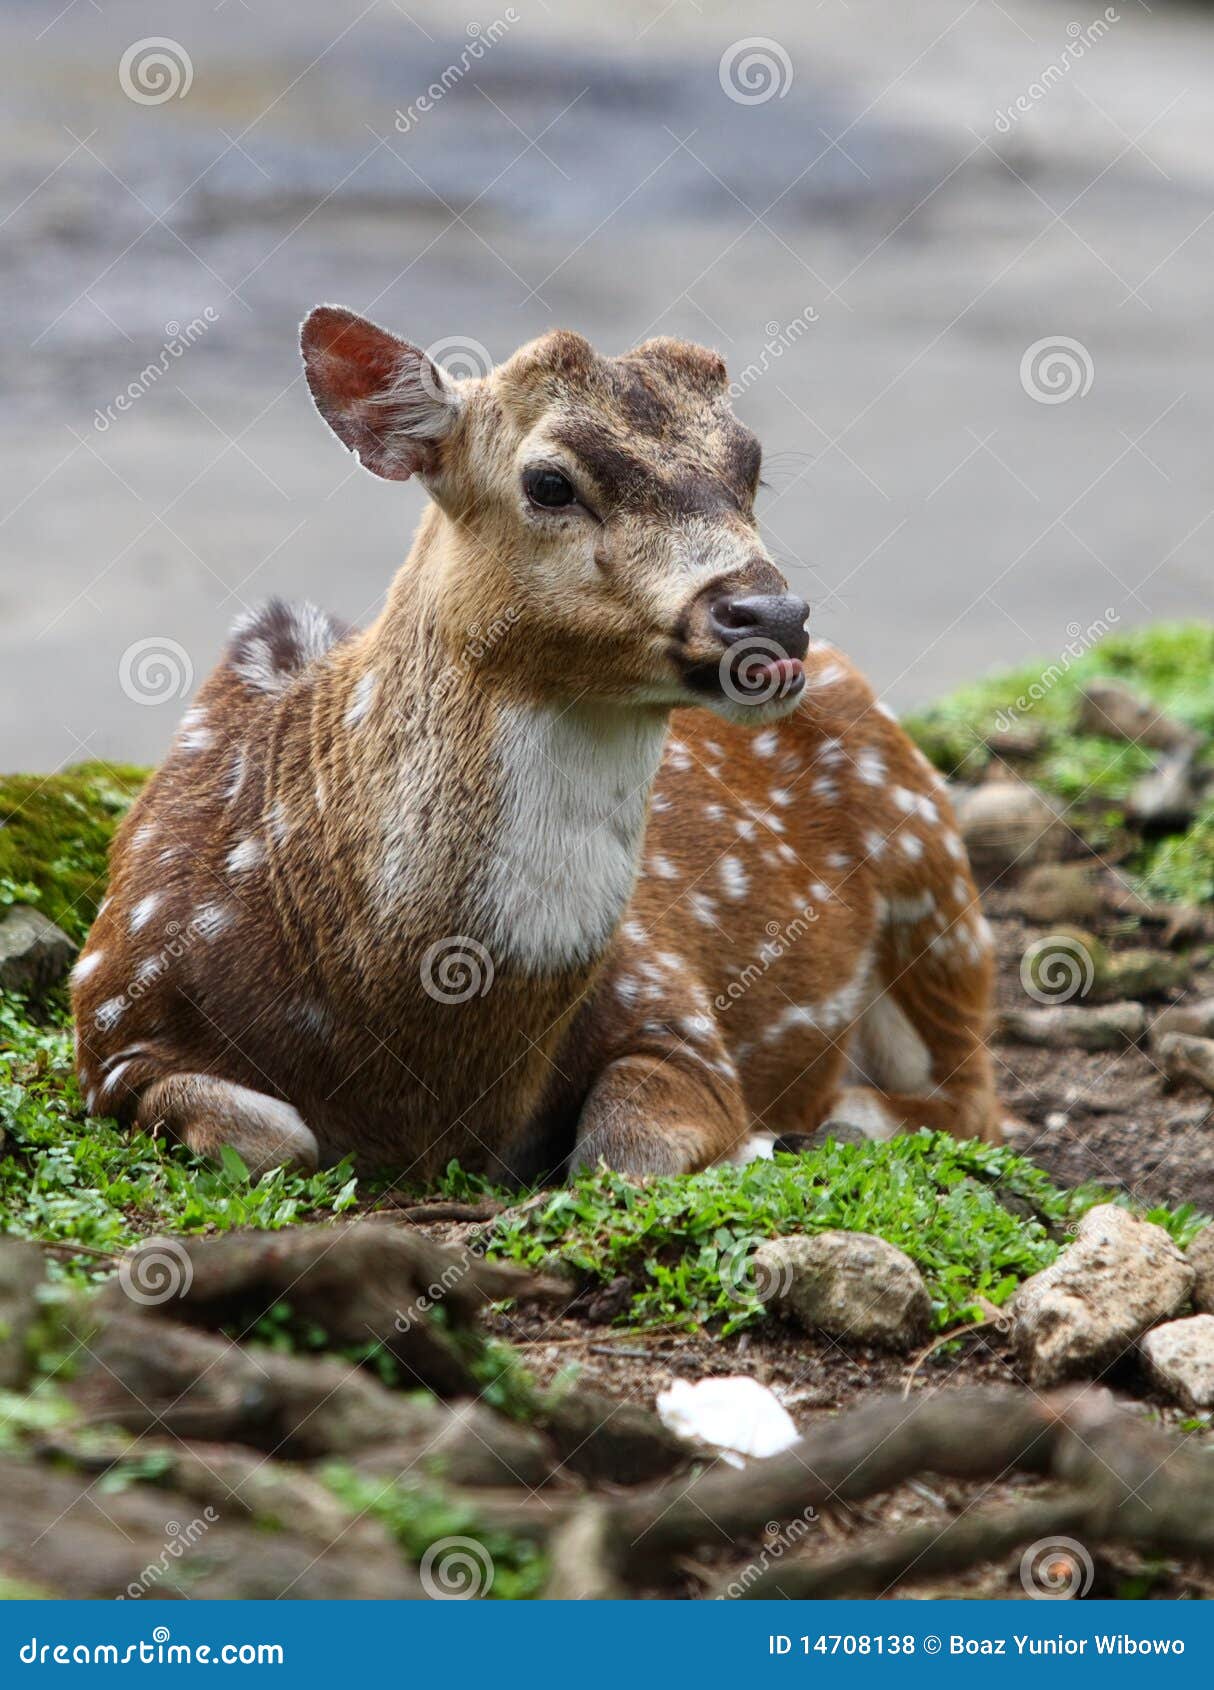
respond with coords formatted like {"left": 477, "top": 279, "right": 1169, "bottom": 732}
{"left": 74, "top": 306, "right": 998, "bottom": 1178}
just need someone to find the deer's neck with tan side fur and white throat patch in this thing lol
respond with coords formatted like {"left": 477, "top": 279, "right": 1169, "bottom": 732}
{"left": 338, "top": 524, "right": 668, "bottom": 980}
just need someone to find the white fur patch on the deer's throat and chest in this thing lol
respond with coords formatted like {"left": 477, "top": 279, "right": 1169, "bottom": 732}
{"left": 482, "top": 705, "right": 666, "bottom": 972}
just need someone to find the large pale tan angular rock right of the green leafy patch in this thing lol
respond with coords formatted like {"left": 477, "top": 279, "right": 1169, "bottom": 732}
{"left": 1011, "top": 1203, "right": 1194, "bottom": 1386}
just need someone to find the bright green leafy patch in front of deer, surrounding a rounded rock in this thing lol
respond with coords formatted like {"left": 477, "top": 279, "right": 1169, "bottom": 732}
{"left": 476, "top": 1132, "right": 1202, "bottom": 1332}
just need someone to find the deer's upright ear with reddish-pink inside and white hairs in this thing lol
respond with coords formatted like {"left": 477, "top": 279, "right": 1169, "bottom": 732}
{"left": 299, "top": 306, "right": 460, "bottom": 482}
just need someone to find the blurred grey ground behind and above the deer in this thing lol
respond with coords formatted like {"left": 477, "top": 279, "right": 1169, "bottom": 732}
{"left": 0, "top": 0, "right": 1214, "bottom": 769}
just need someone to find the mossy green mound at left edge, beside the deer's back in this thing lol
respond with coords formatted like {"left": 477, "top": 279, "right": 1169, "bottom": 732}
{"left": 0, "top": 762, "right": 147, "bottom": 940}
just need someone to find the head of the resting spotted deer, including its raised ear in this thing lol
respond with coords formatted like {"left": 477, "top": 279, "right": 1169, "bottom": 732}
{"left": 303, "top": 306, "right": 808, "bottom": 723}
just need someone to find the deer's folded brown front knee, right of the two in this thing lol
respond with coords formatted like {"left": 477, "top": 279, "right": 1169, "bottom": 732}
{"left": 571, "top": 1053, "right": 746, "bottom": 1175}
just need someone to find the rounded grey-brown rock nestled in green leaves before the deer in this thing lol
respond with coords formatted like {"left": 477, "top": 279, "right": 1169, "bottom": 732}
{"left": 754, "top": 1232, "right": 932, "bottom": 1349}
